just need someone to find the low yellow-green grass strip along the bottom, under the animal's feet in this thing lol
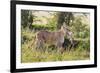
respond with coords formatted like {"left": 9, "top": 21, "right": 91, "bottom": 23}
{"left": 21, "top": 39, "right": 89, "bottom": 63}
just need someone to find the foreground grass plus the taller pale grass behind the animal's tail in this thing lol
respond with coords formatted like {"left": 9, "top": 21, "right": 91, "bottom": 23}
{"left": 21, "top": 29, "right": 90, "bottom": 63}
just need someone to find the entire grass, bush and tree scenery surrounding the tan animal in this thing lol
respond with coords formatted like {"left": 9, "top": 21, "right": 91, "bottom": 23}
{"left": 21, "top": 10, "right": 90, "bottom": 63}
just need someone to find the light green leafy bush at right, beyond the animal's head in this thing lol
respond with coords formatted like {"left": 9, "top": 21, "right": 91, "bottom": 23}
{"left": 72, "top": 16, "right": 90, "bottom": 38}
